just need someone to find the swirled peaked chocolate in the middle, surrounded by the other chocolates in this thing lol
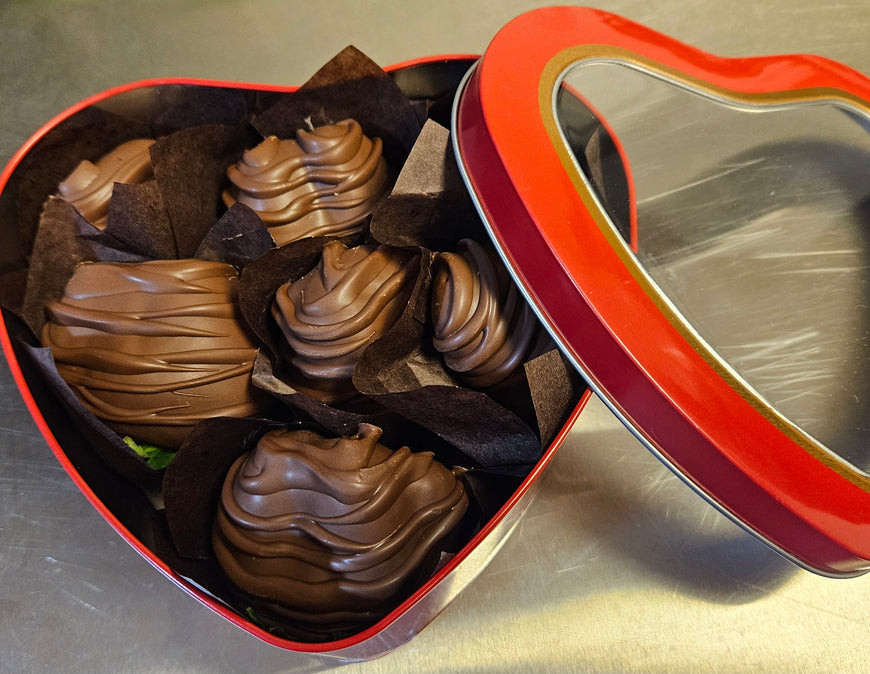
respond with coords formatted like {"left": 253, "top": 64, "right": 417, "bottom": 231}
{"left": 272, "top": 241, "right": 419, "bottom": 388}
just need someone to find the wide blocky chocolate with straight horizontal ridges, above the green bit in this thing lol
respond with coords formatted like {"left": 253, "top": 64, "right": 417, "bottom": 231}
{"left": 42, "top": 260, "right": 259, "bottom": 448}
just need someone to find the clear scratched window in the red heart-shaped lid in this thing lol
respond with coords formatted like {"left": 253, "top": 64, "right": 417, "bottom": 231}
{"left": 557, "top": 62, "right": 870, "bottom": 471}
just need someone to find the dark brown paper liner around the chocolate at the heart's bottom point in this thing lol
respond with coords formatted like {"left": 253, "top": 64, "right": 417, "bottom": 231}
{"left": 157, "top": 418, "right": 508, "bottom": 641}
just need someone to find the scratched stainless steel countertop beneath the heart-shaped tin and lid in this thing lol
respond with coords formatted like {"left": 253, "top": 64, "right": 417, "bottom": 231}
{"left": 0, "top": 0, "right": 870, "bottom": 673}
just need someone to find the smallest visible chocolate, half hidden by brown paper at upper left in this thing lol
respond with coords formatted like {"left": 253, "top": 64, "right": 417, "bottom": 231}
{"left": 58, "top": 138, "right": 154, "bottom": 229}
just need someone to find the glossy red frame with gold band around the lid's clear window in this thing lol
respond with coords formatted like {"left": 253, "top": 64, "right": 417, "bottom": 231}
{"left": 453, "top": 7, "right": 870, "bottom": 576}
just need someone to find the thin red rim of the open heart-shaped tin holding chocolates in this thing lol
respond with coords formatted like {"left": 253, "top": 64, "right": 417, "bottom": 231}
{"left": 0, "top": 55, "right": 590, "bottom": 660}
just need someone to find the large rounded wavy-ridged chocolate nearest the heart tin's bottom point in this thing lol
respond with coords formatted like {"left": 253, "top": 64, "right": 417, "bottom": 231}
{"left": 212, "top": 424, "right": 468, "bottom": 625}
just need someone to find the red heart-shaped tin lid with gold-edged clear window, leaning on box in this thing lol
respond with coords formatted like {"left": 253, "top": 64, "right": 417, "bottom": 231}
{"left": 453, "top": 7, "right": 870, "bottom": 576}
